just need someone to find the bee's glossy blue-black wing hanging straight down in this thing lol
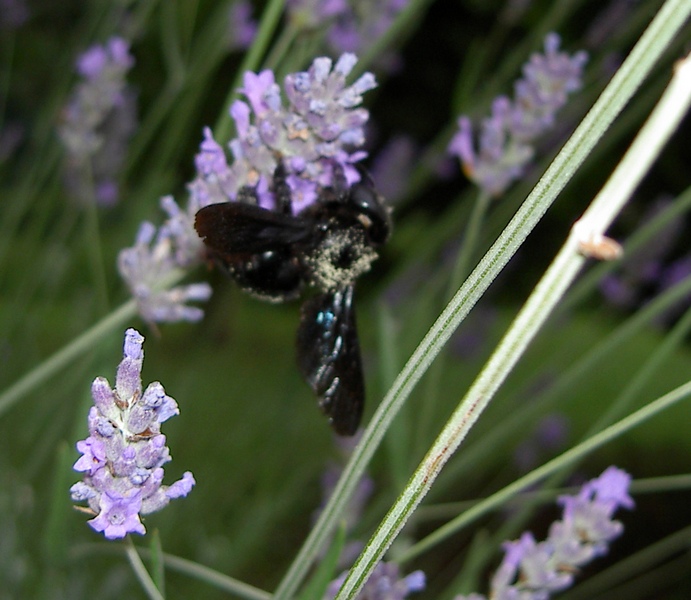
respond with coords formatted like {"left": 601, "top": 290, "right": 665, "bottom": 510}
{"left": 297, "top": 285, "right": 365, "bottom": 435}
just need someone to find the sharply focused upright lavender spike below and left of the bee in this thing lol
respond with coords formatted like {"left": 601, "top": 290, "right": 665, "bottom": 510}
{"left": 70, "top": 329, "right": 195, "bottom": 540}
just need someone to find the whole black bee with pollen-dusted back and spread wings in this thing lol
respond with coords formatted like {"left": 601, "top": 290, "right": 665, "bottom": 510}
{"left": 195, "top": 161, "right": 391, "bottom": 435}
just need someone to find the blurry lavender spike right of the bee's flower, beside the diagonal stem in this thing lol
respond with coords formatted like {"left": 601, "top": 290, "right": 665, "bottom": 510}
{"left": 448, "top": 33, "right": 587, "bottom": 196}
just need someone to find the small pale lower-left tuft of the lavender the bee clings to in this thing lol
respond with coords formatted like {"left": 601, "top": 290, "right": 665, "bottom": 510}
{"left": 118, "top": 217, "right": 211, "bottom": 323}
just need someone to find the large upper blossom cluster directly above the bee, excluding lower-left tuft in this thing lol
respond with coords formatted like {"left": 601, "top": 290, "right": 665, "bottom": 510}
{"left": 189, "top": 54, "right": 376, "bottom": 213}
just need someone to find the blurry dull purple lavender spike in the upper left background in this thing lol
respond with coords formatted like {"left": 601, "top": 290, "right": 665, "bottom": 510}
{"left": 58, "top": 37, "right": 136, "bottom": 205}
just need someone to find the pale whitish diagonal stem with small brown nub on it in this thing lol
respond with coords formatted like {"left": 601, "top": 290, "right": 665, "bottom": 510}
{"left": 336, "top": 43, "right": 691, "bottom": 600}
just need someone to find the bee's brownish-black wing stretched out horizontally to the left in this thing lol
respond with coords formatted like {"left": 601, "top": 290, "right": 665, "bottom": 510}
{"left": 194, "top": 202, "right": 312, "bottom": 257}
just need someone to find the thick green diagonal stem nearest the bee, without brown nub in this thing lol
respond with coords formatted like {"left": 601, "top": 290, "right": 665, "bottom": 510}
{"left": 274, "top": 0, "right": 691, "bottom": 600}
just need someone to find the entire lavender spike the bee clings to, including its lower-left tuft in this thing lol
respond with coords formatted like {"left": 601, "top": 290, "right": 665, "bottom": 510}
{"left": 118, "top": 54, "right": 376, "bottom": 322}
